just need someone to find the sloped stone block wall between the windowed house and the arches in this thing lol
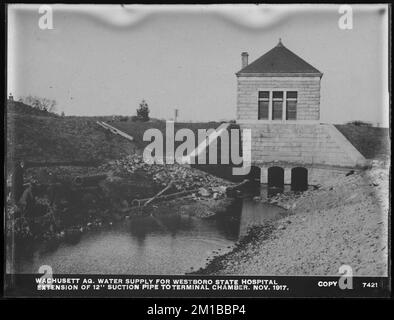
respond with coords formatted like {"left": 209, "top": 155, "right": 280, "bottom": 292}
{"left": 240, "top": 123, "right": 367, "bottom": 167}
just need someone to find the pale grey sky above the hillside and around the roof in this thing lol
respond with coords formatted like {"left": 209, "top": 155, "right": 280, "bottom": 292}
{"left": 7, "top": 4, "right": 389, "bottom": 127}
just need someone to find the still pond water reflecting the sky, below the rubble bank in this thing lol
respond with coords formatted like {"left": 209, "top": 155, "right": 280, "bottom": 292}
{"left": 11, "top": 199, "right": 286, "bottom": 275}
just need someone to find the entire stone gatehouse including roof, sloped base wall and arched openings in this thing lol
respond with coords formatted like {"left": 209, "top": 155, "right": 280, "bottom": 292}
{"left": 236, "top": 40, "right": 367, "bottom": 189}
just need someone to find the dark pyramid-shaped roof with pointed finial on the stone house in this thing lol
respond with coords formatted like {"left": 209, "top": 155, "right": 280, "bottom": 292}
{"left": 236, "top": 39, "right": 323, "bottom": 77}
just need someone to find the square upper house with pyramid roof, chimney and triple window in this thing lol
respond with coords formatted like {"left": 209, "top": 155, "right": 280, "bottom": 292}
{"left": 236, "top": 40, "right": 323, "bottom": 123}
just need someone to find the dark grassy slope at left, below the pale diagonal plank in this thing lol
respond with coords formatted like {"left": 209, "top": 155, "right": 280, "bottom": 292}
{"left": 7, "top": 114, "right": 135, "bottom": 165}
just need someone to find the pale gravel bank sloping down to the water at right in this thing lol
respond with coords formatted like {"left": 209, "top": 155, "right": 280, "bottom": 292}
{"left": 203, "top": 161, "right": 389, "bottom": 276}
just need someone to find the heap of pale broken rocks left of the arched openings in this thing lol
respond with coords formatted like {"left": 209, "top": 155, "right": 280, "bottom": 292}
{"left": 101, "top": 154, "right": 232, "bottom": 191}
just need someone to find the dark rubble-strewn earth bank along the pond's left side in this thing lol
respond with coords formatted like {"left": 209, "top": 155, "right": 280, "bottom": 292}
{"left": 7, "top": 154, "right": 232, "bottom": 240}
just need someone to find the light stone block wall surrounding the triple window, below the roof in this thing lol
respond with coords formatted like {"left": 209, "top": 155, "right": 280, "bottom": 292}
{"left": 237, "top": 77, "right": 320, "bottom": 120}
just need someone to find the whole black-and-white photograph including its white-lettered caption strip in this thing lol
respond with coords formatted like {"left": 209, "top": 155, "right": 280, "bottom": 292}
{"left": 4, "top": 3, "right": 391, "bottom": 298}
